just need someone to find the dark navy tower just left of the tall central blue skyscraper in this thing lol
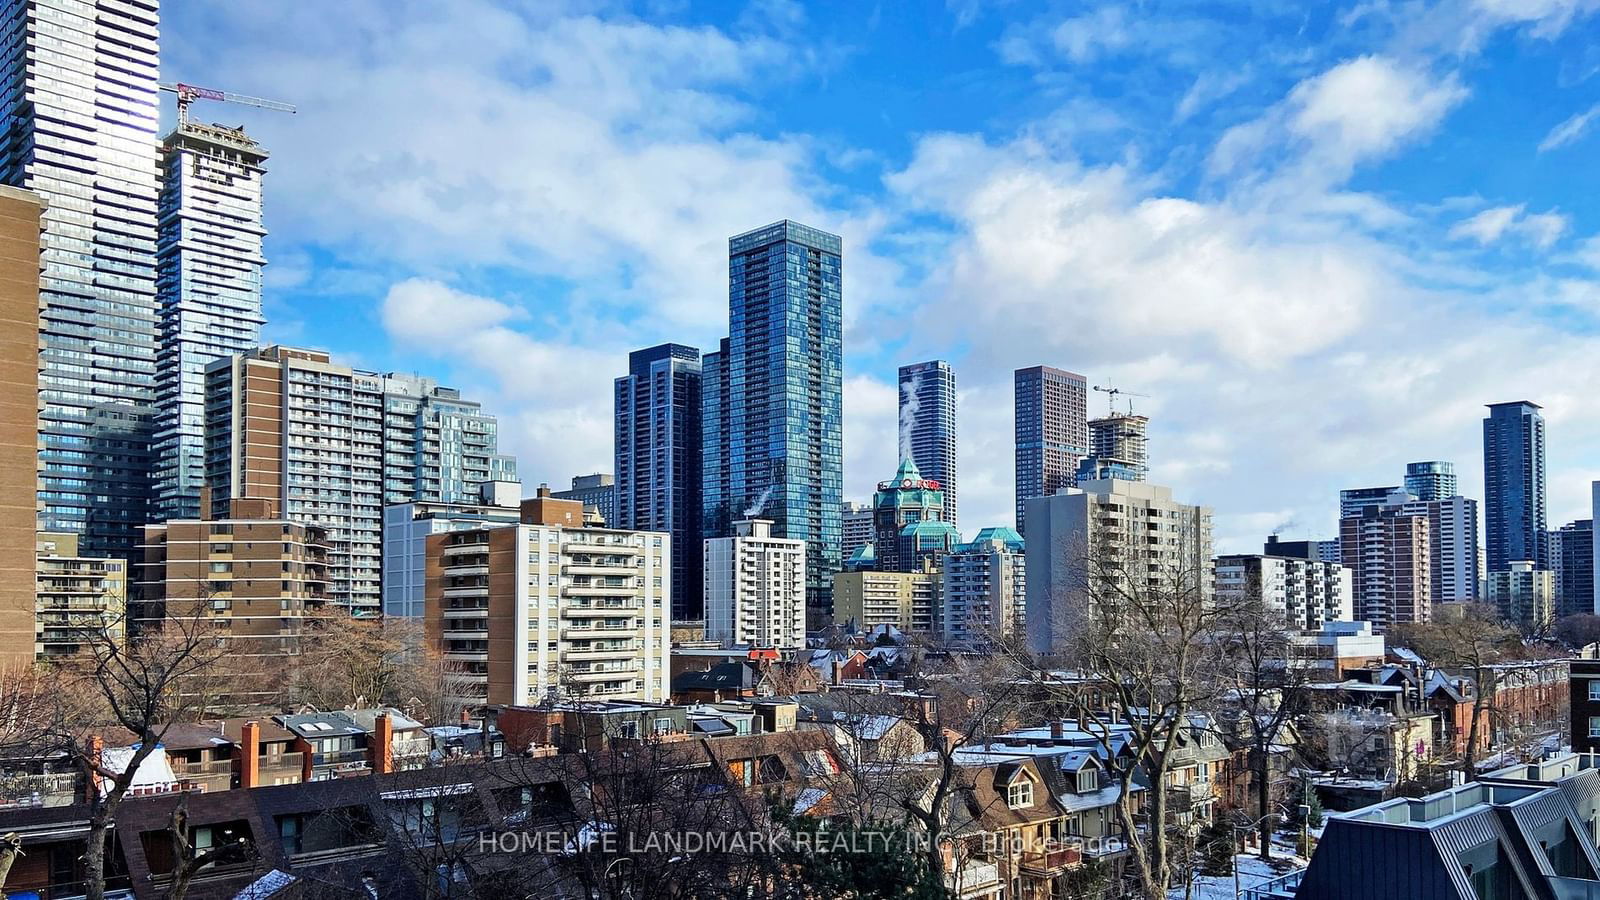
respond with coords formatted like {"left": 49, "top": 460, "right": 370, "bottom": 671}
{"left": 614, "top": 344, "right": 704, "bottom": 620}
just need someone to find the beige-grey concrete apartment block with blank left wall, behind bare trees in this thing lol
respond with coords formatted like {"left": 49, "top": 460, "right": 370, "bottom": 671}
{"left": 1026, "top": 479, "right": 1216, "bottom": 653}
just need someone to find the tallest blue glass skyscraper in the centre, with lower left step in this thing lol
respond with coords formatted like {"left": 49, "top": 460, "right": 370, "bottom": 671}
{"left": 701, "top": 219, "right": 843, "bottom": 626}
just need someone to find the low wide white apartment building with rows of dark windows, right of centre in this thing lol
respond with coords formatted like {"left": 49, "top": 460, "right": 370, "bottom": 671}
{"left": 1216, "top": 554, "right": 1354, "bottom": 631}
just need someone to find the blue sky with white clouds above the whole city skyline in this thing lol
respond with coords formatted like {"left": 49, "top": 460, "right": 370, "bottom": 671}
{"left": 162, "top": 0, "right": 1600, "bottom": 551}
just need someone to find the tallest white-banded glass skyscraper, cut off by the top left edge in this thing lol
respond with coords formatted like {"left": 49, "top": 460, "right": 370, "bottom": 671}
{"left": 0, "top": 0, "right": 160, "bottom": 554}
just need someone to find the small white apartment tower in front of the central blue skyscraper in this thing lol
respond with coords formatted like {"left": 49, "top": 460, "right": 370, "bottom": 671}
{"left": 706, "top": 519, "right": 806, "bottom": 650}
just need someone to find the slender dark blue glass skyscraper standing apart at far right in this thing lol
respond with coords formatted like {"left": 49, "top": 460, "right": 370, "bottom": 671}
{"left": 1483, "top": 400, "right": 1550, "bottom": 572}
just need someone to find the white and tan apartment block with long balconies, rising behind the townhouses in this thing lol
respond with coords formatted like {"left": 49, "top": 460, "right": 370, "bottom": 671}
{"left": 426, "top": 525, "right": 672, "bottom": 703}
